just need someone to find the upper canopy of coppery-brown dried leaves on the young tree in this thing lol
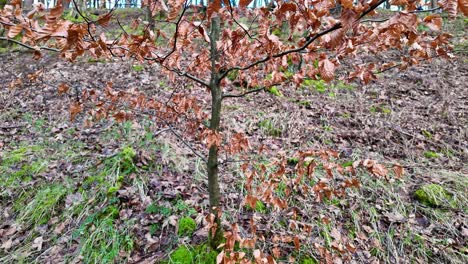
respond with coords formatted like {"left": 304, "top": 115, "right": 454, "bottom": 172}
{"left": 0, "top": 0, "right": 460, "bottom": 88}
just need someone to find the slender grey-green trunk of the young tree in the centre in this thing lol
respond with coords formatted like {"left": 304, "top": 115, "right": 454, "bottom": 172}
{"left": 207, "top": 14, "right": 223, "bottom": 249}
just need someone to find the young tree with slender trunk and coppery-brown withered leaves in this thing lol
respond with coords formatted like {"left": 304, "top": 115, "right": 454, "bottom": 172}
{"left": 0, "top": 0, "right": 467, "bottom": 250}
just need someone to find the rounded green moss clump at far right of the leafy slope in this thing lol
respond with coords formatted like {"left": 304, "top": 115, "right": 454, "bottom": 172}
{"left": 414, "top": 184, "right": 455, "bottom": 207}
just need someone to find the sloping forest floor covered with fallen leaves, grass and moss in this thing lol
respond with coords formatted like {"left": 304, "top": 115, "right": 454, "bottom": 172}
{"left": 0, "top": 8, "right": 468, "bottom": 263}
